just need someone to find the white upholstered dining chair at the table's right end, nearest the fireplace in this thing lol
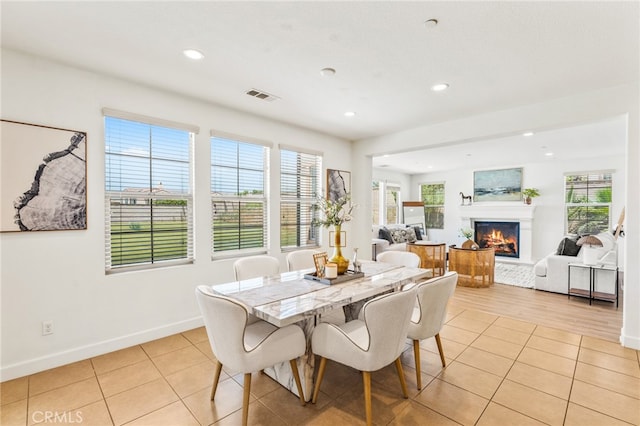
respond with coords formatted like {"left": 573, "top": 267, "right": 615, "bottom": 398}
{"left": 407, "top": 271, "right": 458, "bottom": 390}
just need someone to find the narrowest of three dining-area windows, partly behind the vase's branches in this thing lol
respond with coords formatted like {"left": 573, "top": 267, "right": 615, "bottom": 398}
{"left": 280, "top": 149, "right": 322, "bottom": 250}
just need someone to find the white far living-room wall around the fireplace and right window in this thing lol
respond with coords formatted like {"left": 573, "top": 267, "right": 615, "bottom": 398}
{"left": 411, "top": 155, "right": 626, "bottom": 262}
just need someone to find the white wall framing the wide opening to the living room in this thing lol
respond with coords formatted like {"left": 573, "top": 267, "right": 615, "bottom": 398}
{"left": 352, "top": 83, "right": 640, "bottom": 349}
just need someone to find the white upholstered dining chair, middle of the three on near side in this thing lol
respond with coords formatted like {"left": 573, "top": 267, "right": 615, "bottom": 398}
{"left": 311, "top": 287, "right": 416, "bottom": 425}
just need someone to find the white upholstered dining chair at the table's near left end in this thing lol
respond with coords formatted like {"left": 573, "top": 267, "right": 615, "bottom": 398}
{"left": 196, "top": 286, "right": 306, "bottom": 425}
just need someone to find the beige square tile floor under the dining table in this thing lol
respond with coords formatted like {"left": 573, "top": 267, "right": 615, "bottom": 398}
{"left": 0, "top": 309, "right": 640, "bottom": 426}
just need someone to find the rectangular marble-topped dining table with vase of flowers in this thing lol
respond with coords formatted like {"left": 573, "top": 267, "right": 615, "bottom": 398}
{"left": 211, "top": 262, "right": 430, "bottom": 401}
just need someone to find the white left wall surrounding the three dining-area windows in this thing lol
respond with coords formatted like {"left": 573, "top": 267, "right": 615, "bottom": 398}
{"left": 0, "top": 50, "right": 352, "bottom": 380}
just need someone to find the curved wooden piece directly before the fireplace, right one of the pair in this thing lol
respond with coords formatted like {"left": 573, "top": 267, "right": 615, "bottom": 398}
{"left": 449, "top": 247, "right": 495, "bottom": 287}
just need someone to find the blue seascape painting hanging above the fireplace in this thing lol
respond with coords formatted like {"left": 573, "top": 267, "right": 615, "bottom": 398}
{"left": 473, "top": 167, "right": 522, "bottom": 202}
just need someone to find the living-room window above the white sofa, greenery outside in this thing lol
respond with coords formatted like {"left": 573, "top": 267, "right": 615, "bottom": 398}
{"left": 564, "top": 172, "right": 612, "bottom": 234}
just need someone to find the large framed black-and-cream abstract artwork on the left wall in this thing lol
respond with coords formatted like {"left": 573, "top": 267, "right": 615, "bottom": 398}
{"left": 0, "top": 120, "right": 87, "bottom": 232}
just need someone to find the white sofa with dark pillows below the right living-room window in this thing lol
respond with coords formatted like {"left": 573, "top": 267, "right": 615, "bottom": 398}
{"left": 533, "top": 232, "right": 617, "bottom": 294}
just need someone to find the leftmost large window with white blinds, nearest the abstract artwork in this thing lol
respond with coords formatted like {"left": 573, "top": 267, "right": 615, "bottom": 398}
{"left": 105, "top": 112, "right": 194, "bottom": 271}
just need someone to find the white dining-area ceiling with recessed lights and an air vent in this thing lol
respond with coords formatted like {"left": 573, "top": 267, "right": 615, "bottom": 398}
{"left": 1, "top": 1, "right": 640, "bottom": 167}
